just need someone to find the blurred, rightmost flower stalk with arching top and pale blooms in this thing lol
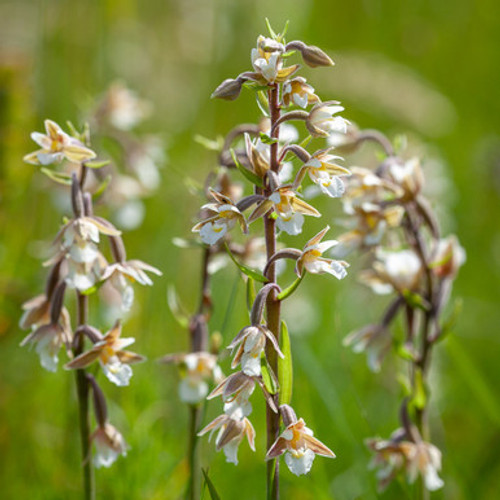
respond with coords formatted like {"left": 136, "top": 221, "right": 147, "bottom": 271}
{"left": 335, "top": 127, "right": 465, "bottom": 498}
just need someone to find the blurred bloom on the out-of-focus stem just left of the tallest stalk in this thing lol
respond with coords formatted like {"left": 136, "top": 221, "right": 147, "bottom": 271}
{"left": 160, "top": 351, "right": 222, "bottom": 404}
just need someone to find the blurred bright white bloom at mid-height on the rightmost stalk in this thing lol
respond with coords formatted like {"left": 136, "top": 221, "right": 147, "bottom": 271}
{"left": 360, "top": 250, "right": 423, "bottom": 295}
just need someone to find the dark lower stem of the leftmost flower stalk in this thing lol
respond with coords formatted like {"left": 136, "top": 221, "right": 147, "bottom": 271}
{"left": 73, "top": 291, "right": 95, "bottom": 500}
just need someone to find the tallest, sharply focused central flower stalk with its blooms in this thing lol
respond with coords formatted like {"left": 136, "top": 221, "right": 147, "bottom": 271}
{"left": 193, "top": 25, "right": 350, "bottom": 499}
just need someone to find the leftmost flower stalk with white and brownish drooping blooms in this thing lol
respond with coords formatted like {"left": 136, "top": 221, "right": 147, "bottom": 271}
{"left": 20, "top": 120, "right": 161, "bottom": 499}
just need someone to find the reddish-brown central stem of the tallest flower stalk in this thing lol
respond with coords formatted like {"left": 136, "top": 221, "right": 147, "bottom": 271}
{"left": 264, "top": 83, "right": 280, "bottom": 500}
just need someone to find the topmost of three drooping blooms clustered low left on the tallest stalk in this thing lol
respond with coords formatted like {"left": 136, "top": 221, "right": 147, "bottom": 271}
{"left": 228, "top": 325, "right": 284, "bottom": 377}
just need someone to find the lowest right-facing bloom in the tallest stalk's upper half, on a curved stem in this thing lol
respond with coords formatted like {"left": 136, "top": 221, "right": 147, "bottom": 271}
{"left": 295, "top": 226, "right": 349, "bottom": 280}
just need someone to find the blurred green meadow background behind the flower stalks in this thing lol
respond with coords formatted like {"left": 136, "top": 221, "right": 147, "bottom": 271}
{"left": 0, "top": 0, "right": 500, "bottom": 500}
